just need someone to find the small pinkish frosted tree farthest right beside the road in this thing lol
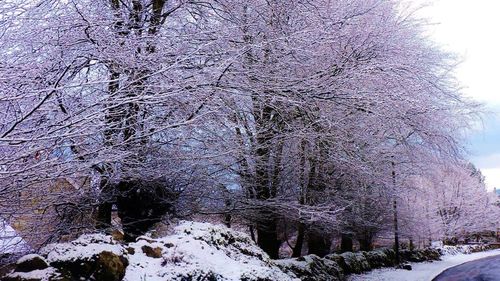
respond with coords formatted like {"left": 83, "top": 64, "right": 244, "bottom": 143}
{"left": 402, "top": 163, "right": 497, "bottom": 242}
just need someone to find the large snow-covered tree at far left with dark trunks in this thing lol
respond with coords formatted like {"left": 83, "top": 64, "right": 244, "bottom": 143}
{"left": 0, "top": 0, "right": 223, "bottom": 243}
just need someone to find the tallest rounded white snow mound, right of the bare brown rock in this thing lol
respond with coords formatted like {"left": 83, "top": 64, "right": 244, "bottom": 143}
{"left": 124, "top": 222, "right": 298, "bottom": 281}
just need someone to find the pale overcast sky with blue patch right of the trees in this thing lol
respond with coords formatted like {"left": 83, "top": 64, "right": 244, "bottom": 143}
{"left": 407, "top": 0, "right": 500, "bottom": 189}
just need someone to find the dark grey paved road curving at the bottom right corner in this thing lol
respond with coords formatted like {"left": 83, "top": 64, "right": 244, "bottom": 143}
{"left": 432, "top": 256, "right": 500, "bottom": 281}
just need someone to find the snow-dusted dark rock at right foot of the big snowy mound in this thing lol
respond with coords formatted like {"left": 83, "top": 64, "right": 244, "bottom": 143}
{"left": 277, "top": 255, "right": 344, "bottom": 281}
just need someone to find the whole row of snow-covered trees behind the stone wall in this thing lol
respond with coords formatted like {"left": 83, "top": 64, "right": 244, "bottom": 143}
{"left": 0, "top": 0, "right": 500, "bottom": 259}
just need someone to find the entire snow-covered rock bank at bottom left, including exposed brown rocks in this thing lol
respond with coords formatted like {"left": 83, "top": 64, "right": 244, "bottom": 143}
{"left": 6, "top": 222, "right": 300, "bottom": 281}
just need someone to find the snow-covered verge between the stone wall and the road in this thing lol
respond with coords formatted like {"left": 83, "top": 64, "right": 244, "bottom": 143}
{"left": 348, "top": 249, "right": 500, "bottom": 281}
